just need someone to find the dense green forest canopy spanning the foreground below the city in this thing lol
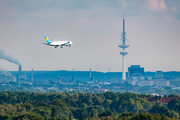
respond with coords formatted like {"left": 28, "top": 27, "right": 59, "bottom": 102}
{"left": 0, "top": 91, "right": 180, "bottom": 120}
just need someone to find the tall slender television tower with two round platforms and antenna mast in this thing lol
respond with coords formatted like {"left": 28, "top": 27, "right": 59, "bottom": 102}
{"left": 119, "top": 11, "right": 129, "bottom": 80}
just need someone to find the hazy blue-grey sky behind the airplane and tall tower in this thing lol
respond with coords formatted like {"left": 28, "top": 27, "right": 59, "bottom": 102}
{"left": 0, "top": 0, "right": 180, "bottom": 72}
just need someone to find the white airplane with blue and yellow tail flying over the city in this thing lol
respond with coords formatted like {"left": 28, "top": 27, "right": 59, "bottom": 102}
{"left": 42, "top": 35, "right": 73, "bottom": 48}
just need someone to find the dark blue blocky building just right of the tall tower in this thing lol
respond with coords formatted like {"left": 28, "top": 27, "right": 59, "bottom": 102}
{"left": 128, "top": 65, "right": 144, "bottom": 80}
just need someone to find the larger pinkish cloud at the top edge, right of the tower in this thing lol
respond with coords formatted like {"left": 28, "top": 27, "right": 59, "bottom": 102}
{"left": 145, "top": 0, "right": 167, "bottom": 11}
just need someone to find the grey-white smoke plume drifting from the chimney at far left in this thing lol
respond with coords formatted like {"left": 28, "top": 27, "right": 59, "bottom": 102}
{"left": 0, "top": 49, "right": 21, "bottom": 65}
